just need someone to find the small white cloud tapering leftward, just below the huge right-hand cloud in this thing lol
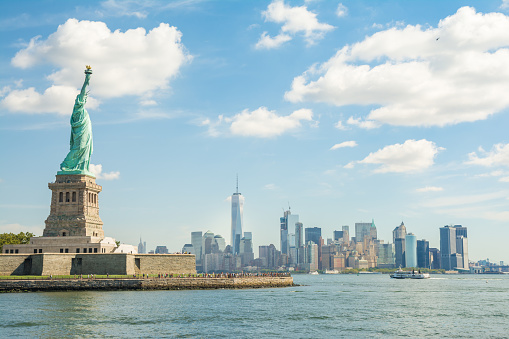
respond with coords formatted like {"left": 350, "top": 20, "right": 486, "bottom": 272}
{"left": 354, "top": 139, "right": 444, "bottom": 173}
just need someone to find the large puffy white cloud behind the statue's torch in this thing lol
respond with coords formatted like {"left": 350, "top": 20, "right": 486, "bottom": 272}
{"left": 4, "top": 19, "right": 191, "bottom": 112}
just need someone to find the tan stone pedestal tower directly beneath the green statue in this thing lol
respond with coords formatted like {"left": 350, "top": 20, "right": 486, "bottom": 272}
{"left": 43, "top": 174, "right": 104, "bottom": 239}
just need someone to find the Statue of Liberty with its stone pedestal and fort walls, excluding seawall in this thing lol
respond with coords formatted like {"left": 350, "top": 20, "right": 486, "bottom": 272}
{"left": 0, "top": 66, "right": 196, "bottom": 276}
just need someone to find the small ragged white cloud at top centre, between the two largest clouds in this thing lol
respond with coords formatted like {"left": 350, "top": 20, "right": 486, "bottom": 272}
{"left": 256, "top": 0, "right": 334, "bottom": 48}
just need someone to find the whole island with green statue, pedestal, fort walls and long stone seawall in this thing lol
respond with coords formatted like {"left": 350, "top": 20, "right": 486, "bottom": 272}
{"left": 0, "top": 66, "right": 293, "bottom": 291}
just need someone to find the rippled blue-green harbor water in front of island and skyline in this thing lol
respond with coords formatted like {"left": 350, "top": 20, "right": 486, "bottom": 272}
{"left": 0, "top": 274, "right": 509, "bottom": 338}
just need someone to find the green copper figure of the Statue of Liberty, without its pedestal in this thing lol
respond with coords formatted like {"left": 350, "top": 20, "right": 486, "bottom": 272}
{"left": 57, "top": 66, "right": 95, "bottom": 177}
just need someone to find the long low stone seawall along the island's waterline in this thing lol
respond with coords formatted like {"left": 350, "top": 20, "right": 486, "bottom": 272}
{"left": 0, "top": 276, "right": 294, "bottom": 292}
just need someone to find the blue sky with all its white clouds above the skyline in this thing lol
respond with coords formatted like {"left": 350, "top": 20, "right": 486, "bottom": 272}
{"left": 0, "top": 0, "right": 509, "bottom": 261}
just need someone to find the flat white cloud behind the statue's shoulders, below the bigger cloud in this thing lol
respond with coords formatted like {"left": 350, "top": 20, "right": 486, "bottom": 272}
{"left": 1, "top": 86, "right": 99, "bottom": 115}
